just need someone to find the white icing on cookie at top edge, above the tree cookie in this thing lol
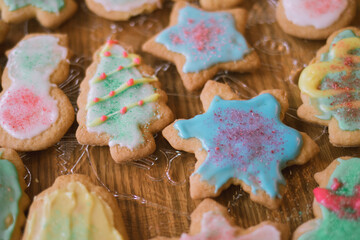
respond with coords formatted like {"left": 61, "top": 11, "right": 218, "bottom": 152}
{"left": 94, "top": 0, "right": 161, "bottom": 12}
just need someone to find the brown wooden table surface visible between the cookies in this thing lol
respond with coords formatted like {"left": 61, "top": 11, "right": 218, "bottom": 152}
{"left": 0, "top": 0, "right": 360, "bottom": 239}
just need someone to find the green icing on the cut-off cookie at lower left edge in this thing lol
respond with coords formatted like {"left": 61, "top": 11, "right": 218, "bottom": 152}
{"left": 0, "top": 159, "right": 22, "bottom": 240}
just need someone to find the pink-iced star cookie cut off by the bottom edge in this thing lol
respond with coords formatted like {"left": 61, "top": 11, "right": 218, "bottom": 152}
{"left": 152, "top": 199, "right": 289, "bottom": 240}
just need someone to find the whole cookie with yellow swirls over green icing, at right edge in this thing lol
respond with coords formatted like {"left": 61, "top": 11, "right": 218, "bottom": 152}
{"left": 297, "top": 28, "right": 360, "bottom": 147}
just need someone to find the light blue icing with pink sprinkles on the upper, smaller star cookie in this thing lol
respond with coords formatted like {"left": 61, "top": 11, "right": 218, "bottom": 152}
{"left": 155, "top": 6, "right": 249, "bottom": 73}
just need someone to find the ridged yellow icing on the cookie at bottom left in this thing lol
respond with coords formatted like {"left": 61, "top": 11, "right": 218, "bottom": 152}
{"left": 24, "top": 182, "right": 123, "bottom": 240}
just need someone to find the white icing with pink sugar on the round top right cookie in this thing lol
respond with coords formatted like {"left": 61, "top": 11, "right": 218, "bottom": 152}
{"left": 283, "top": 0, "right": 348, "bottom": 29}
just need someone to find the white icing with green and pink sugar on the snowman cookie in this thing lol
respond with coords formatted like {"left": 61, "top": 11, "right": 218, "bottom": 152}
{"left": 0, "top": 36, "right": 67, "bottom": 139}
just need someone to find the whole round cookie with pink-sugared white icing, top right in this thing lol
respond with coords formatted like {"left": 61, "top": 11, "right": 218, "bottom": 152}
{"left": 276, "top": 0, "right": 356, "bottom": 40}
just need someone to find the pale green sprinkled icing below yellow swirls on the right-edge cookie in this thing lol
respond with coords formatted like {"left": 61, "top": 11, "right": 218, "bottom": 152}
{"left": 310, "top": 30, "right": 360, "bottom": 131}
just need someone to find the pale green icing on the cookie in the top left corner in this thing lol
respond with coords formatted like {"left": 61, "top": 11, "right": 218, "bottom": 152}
{"left": 4, "top": 0, "right": 65, "bottom": 13}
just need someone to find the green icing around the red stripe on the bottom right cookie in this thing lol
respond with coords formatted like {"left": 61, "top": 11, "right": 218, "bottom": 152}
{"left": 299, "top": 158, "right": 360, "bottom": 240}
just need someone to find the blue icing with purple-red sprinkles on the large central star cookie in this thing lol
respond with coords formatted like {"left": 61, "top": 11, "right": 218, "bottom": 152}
{"left": 174, "top": 94, "right": 302, "bottom": 198}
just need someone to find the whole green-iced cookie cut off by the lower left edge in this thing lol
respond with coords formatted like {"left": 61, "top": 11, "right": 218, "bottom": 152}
{"left": 0, "top": 148, "right": 29, "bottom": 240}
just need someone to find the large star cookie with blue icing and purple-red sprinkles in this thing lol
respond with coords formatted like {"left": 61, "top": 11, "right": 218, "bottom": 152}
{"left": 163, "top": 81, "right": 319, "bottom": 209}
